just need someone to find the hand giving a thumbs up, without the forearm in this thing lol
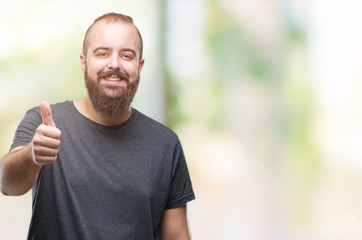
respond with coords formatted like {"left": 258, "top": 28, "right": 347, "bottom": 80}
{"left": 32, "top": 101, "right": 61, "bottom": 166}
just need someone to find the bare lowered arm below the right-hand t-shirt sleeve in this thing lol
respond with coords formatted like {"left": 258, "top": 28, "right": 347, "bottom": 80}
{"left": 161, "top": 204, "right": 191, "bottom": 240}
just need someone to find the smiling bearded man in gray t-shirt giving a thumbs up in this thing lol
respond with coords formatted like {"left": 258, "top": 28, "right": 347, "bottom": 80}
{"left": 0, "top": 13, "right": 195, "bottom": 240}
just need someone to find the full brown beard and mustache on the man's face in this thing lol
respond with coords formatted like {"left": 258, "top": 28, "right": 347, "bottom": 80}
{"left": 84, "top": 67, "right": 140, "bottom": 116}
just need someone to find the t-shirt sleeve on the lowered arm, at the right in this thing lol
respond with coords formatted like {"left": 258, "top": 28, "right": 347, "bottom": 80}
{"left": 166, "top": 141, "right": 195, "bottom": 209}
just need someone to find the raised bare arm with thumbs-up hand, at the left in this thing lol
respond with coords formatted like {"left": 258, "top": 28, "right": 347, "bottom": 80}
{"left": 0, "top": 102, "right": 61, "bottom": 196}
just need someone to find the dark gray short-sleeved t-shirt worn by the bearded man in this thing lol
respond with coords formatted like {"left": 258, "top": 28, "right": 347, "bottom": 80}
{"left": 11, "top": 101, "right": 195, "bottom": 240}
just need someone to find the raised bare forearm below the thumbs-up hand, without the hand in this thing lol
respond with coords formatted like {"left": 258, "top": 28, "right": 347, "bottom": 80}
{"left": 0, "top": 143, "right": 41, "bottom": 196}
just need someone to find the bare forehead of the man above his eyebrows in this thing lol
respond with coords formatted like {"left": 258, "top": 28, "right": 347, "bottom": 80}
{"left": 86, "top": 20, "right": 141, "bottom": 53}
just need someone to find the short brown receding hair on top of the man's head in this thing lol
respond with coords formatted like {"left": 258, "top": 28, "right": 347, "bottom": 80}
{"left": 83, "top": 12, "right": 143, "bottom": 60}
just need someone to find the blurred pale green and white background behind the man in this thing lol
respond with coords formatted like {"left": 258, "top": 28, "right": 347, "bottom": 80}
{"left": 0, "top": 0, "right": 362, "bottom": 240}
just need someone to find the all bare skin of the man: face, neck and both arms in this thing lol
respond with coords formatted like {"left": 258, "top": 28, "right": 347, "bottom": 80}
{"left": 0, "top": 21, "right": 190, "bottom": 240}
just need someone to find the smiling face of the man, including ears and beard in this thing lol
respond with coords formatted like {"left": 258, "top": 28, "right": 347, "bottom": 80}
{"left": 80, "top": 21, "right": 144, "bottom": 115}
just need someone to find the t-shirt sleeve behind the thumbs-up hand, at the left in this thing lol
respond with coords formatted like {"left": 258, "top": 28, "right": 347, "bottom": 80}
{"left": 10, "top": 107, "right": 42, "bottom": 150}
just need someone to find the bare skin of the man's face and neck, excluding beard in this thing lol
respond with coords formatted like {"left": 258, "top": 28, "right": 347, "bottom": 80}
{"left": 75, "top": 21, "right": 144, "bottom": 125}
